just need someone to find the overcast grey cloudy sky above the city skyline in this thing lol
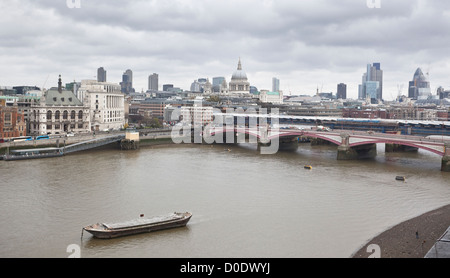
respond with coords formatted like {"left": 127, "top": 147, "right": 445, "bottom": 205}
{"left": 0, "top": 0, "right": 450, "bottom": 99}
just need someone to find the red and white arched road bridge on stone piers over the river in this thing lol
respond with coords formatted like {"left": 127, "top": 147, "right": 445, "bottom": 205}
{"left": 203, "top": 127, "right": 450, "bottom": 172}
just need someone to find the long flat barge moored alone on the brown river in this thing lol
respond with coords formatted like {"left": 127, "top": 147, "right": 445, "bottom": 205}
{"left": 82, "top": 212, "right": 192, "bottom": 239}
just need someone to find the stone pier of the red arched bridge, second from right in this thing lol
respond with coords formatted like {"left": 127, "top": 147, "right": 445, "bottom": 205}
{"left": 337, "top": 134, "right": 377, "bottom": 160}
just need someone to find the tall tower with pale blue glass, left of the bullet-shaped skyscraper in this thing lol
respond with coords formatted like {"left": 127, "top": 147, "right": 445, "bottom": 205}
{"left": 358, "top": 63, "right": 383, "bottom": 103}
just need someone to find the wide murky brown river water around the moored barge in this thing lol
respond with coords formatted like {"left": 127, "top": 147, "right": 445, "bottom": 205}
{"left": 0, "top": 144, "right": 450, "bottom": 258}
